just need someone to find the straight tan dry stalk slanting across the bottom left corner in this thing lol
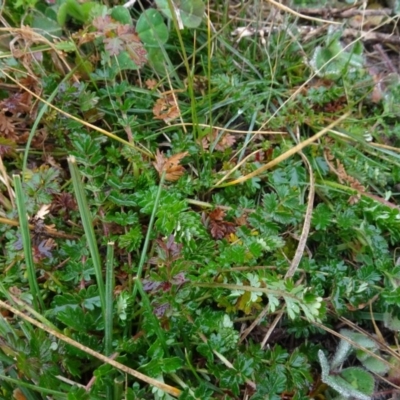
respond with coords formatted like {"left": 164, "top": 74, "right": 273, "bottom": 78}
{"left": 0, "top": 300, "right": 181, "bottom": 397}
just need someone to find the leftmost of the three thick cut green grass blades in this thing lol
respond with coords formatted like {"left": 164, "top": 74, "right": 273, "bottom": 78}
{"left": 13, "top": 175, "right": 44, "bottom": 311}
